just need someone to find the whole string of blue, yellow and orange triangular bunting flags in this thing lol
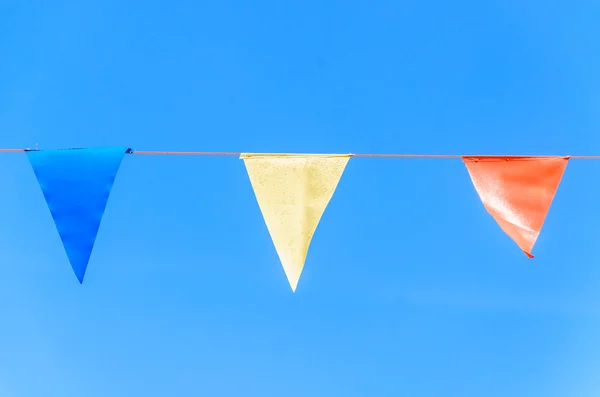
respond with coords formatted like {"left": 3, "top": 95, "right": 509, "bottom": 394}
{"left": 5, "top": 147, "right": 576, "bottom": 291}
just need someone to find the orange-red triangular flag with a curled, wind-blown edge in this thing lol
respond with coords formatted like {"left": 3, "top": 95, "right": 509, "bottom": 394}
{"left": 463, "top": 156, "right": 569, "bottom": 258}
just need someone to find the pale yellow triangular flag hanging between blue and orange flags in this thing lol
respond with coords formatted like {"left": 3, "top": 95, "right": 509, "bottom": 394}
{"left": 240, "top": 153, "right": 351, "bottom": 292}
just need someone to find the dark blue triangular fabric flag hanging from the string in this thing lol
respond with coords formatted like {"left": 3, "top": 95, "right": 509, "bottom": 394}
{"left": 27, "top": 147, "right": 131, "bottom": 283}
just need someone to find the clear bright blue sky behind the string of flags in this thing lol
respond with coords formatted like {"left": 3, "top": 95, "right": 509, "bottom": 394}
{"left": 0, "top": 0, "right": 600, "bottom": 397}
